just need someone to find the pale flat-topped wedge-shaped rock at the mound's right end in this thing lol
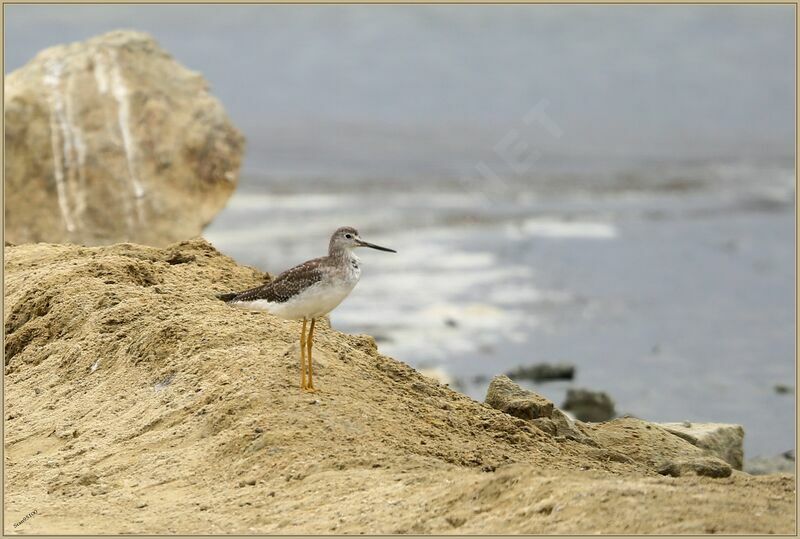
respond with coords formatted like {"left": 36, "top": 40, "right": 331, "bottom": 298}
{"left": 658, "top": 421, "right": 744, "bottom": 470}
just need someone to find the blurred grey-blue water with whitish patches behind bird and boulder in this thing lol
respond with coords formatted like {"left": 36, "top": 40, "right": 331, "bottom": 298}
{"left": 5, "top": 5, "right": 796, "bottom": 457}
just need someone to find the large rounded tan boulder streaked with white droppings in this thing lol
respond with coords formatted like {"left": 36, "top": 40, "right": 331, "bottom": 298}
{"left": 5, "top": 31, "right": 244, "bottom": 245}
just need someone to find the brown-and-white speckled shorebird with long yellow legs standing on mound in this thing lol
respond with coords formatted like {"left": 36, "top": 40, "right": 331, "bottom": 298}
{"left": 217, "top": 226, "right": 397, "bottom": 391}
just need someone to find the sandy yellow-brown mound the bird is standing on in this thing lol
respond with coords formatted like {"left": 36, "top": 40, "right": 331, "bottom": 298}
{"left": 4, "top": 240, "right": 794, "bottom": 534}
